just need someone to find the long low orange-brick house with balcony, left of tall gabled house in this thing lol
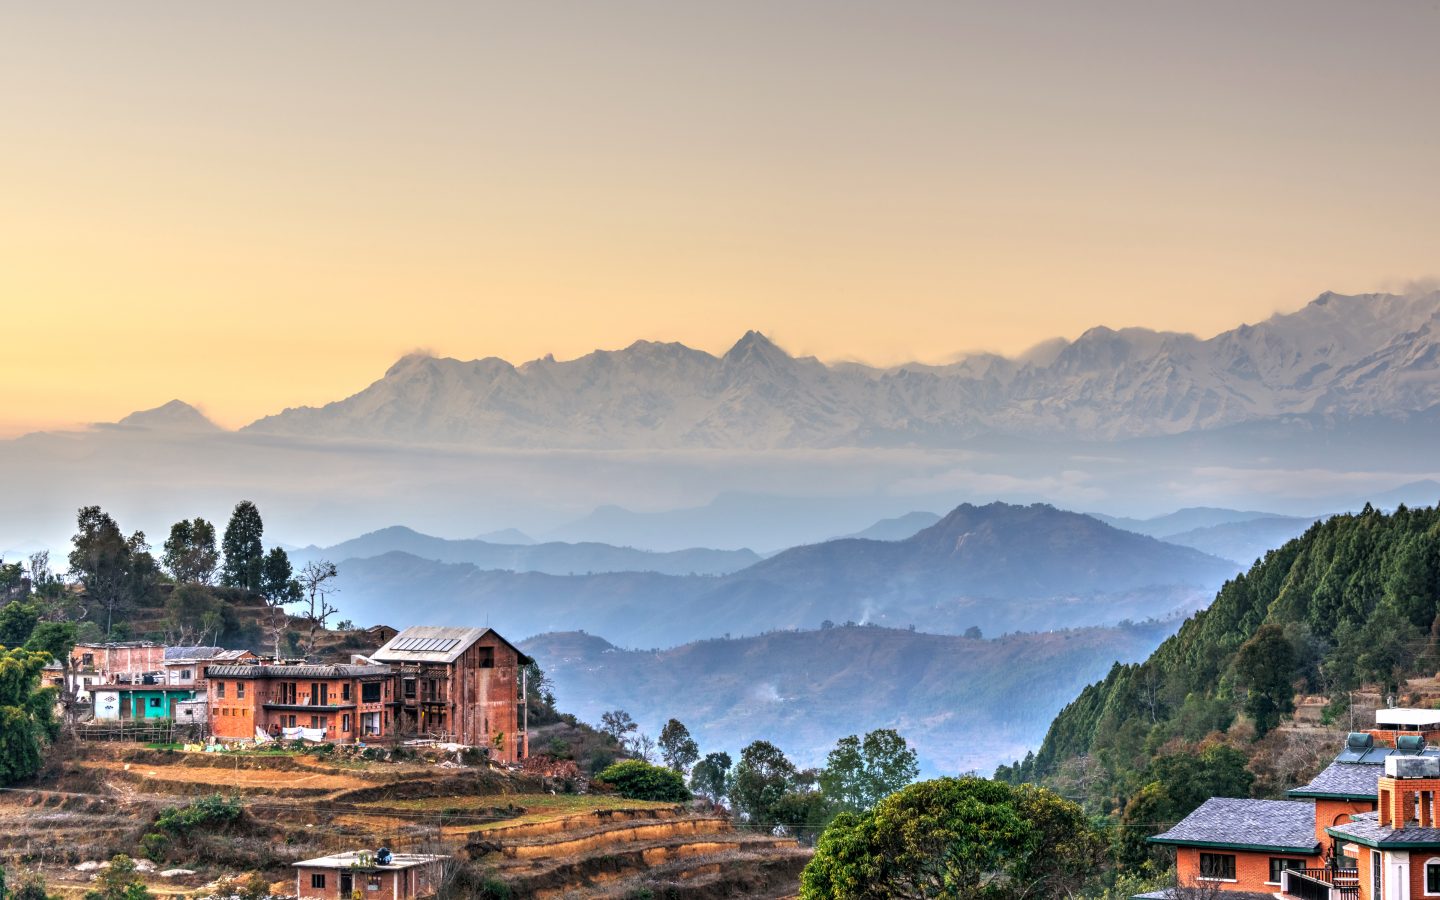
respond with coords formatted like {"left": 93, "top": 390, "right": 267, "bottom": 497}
{"left": 206, "top": 664, "right": 395, "bottom": 743}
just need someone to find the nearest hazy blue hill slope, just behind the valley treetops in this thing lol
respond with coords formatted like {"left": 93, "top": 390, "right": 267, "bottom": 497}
{"left": 521, "top": 624, "right": 1175, "bottom": 773}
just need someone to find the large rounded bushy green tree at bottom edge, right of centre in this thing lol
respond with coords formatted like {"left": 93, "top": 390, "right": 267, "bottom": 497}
{"left": 801, "top": 778, "right": 1104, "bottom": 900}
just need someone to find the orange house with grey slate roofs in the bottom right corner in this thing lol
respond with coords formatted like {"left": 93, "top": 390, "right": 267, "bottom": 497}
{"left": 1138, "top": 710, "right": 1440, "bottom": 900}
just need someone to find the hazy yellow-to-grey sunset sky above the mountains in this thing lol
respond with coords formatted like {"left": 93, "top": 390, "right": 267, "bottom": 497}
{"left": 0, "top": 0, "right": 1440, "bottom": 433}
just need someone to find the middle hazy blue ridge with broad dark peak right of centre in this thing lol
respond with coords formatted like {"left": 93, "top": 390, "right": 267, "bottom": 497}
{"left": 329, "top": 503, "right": 1236, "bottom": 647}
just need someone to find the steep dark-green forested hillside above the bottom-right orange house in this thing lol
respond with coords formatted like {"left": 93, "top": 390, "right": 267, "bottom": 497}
{"left": 996, "top": 505, "right": 1440, "bottom": 864}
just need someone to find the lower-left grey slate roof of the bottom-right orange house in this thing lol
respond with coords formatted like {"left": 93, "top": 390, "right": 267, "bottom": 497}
{"left": 1151, "top": 796, "right": 1318, "bottom": 852}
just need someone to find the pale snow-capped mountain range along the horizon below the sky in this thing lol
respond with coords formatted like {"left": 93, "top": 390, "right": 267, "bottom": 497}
{"left": 224, "top": 291, "right": 1440, "bottom": 449}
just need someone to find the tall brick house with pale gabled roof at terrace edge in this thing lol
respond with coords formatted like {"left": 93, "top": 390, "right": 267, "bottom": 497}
{"left": 370, "top": 625, "right": 531, "bottom": 762}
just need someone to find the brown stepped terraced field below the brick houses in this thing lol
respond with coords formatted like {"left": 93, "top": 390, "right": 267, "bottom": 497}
{"left": 0, "top": 744, "right": 809, "bottom": 900}
